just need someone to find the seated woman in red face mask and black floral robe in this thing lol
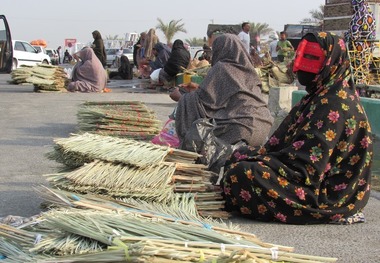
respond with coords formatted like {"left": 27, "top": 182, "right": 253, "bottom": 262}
{"left": 222, "top": 32, "right": 373, "bottom": 224}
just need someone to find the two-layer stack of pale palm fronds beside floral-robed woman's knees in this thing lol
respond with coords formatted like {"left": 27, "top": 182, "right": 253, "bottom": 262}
{"left": 46, "top": 133, "right": 224, "bottom": 218}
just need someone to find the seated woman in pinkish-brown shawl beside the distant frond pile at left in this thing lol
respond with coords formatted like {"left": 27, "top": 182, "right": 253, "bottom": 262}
{"left": 67, "top": 48, "right": 107, "bottom": 92}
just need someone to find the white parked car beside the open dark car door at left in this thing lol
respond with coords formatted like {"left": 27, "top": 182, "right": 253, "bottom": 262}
{"left": 12, "top": 40, "right": 51, "bottom": 70}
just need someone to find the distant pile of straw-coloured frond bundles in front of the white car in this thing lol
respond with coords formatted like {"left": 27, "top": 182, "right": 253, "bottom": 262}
{"left": 11, "top": 64, "right": 68, "bottom": 92}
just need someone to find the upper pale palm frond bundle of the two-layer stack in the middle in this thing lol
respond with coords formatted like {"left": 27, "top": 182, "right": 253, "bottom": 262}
{"left": 47, "top": 133, "right": 200, "bottom": 168}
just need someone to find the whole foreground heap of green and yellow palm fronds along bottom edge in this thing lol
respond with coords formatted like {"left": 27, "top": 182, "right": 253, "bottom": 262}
{"left": 0, "top": 209, "right": 337, "bottom": 263}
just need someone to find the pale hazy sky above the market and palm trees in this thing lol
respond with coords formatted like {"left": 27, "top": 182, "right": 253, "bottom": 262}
{"left": 0, "top": 0, "right": 325, "bottom": 48}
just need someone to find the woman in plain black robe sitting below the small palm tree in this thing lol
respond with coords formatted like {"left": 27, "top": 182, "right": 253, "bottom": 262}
{"left": 159, "top": 39, "right": 190, "bottom": 82}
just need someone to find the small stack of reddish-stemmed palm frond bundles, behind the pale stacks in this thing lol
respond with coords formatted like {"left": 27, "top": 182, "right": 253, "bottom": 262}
{"left": 77, "top": 101, "right": 160, "bottom": 140}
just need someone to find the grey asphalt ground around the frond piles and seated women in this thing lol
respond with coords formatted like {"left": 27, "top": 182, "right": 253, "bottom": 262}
{"left": 0, "top": 74, "right": 380, "bottom": 263}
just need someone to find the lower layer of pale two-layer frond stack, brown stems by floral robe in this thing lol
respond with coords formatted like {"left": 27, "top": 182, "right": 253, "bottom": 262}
{"left": 45, "top": 161, "right": 224, "bottom": 218}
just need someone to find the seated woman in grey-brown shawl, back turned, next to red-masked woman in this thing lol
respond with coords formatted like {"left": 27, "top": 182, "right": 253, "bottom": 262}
{"left": 170, "top": 34, "right": 273, "bottom": 145}
